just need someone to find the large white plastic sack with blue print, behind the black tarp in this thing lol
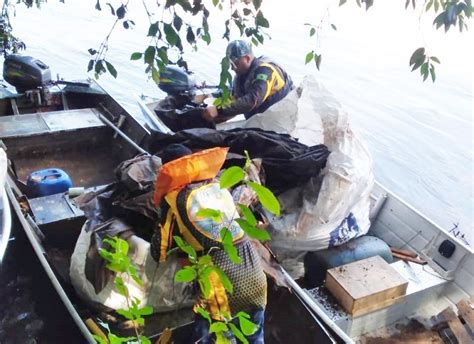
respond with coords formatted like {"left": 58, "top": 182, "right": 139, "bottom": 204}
{"left": 222, "top": 76, "right": 374, "bottom": 255}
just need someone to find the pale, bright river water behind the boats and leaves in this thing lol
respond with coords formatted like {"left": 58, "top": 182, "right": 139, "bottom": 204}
{"left": 6, "top": 0, "right": 474, "bottom": 240}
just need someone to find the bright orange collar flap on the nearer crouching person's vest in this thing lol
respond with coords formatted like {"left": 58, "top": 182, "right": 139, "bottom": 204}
{"left": 154, "top": 147, "right": 229, "bottom": 206}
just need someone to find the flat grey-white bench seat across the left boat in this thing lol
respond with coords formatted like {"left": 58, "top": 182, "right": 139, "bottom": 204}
{"left": 0, "top": 108, "right": 106, "bottom": 139}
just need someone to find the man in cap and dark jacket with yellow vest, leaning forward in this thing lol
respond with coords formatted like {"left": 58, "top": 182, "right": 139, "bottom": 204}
{"left": 203, "top": 40, "right": 293, "bottom": 122}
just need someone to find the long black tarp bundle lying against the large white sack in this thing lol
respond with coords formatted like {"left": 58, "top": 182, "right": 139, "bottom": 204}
{"left": 147, "top": 128, "right": 329, "bottom": 193}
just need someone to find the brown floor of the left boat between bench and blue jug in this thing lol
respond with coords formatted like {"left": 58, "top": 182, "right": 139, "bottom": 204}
{"left": 14, "top": 147, "right": 121, "bottom": 187}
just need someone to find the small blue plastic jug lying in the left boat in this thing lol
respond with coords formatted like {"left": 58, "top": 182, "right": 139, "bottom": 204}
{"left": 26, "top": 168, "right": 72, "bottom": 197}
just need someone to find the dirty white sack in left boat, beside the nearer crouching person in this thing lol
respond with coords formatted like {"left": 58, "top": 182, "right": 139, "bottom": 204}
{"left": 69, "top": 225, "right": 193, "bottom": 312}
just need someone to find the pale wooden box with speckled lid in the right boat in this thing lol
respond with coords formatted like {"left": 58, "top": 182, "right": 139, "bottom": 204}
{"left": 325, "top": 256, "right": 408, "bottom": 316}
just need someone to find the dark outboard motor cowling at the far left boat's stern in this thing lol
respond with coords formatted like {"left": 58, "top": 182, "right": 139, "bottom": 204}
{"left": 3, "top": 54, "right": 51, "bottom": 93}
